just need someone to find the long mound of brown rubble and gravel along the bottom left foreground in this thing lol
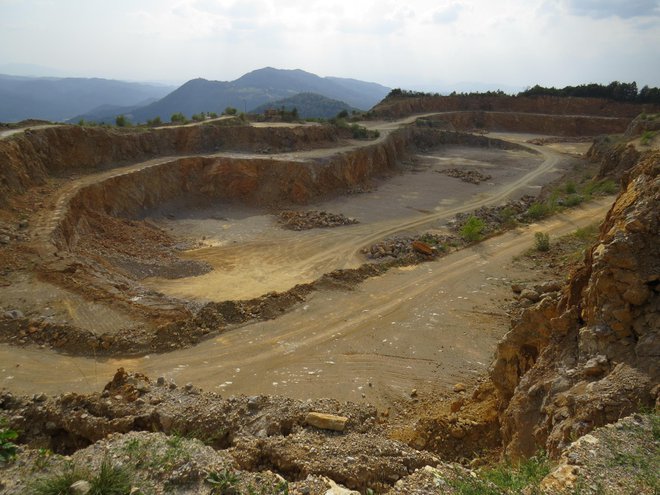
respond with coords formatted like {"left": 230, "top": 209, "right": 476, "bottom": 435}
{"left": 0, "top": 370, "right": 439, "bottom": 494}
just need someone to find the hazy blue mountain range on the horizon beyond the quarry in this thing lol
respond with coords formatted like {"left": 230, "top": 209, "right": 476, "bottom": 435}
{"left": 0, "top": 67, "right": 390, "bottom": 123}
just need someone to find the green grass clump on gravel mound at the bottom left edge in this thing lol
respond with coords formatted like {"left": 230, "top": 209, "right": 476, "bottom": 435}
{"left": 32, "top": 460, "right": 133, "bottom": 495}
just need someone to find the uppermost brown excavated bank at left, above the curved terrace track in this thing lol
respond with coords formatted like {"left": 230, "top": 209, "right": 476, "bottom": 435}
{"left": 0, "top": 124, "right": 339, "bottom": 205}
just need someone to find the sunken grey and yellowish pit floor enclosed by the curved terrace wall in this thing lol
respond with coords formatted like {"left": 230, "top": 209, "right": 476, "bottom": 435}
{"left": 144, "top": 146, "right": 547, "bottom": 301}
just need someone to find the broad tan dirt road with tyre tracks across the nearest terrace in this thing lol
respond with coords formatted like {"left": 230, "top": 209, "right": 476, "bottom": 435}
{"left": 0, "top": 199, "right": 611, "bottom": 408}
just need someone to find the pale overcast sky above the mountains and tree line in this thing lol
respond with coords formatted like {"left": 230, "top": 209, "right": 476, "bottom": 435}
{"left": 0, "top": 0, "right": 660, "bottom": 89}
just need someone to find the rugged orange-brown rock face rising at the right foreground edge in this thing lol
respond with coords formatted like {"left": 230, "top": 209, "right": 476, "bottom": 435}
{"left": 491, "top": 152, "right": 660, "bottom": 458}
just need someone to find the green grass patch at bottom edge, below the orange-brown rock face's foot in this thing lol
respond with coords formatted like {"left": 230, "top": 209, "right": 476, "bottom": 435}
{"left": 449, "top": 454, "right": 550, "bottom": 495}
